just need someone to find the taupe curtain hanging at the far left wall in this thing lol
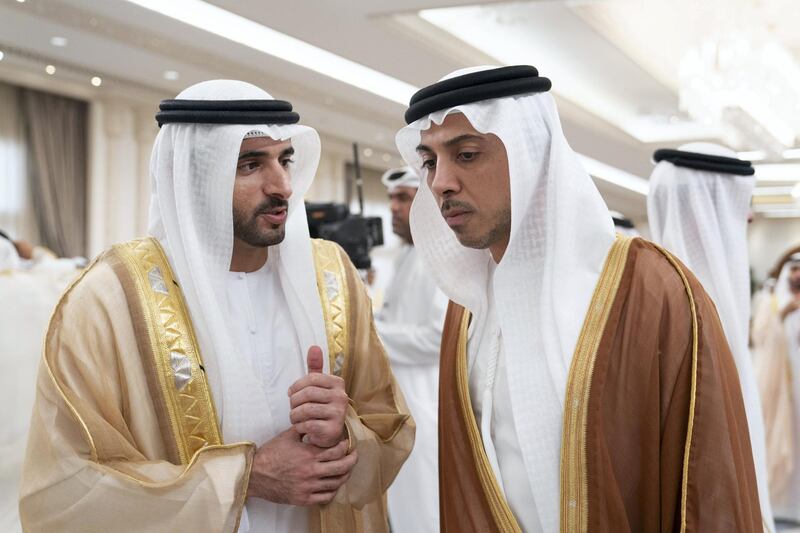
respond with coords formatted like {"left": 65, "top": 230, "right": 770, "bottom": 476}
{"left": 20, "top": 89, "right": 88, "bottom": 257}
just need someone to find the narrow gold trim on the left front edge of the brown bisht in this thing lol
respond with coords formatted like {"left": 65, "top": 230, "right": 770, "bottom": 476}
{"left": 456, "top": 309, "right": 522, "bottom": 533}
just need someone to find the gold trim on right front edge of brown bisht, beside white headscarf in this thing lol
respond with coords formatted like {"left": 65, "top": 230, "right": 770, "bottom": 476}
{"left": 561, "top": 235, "right": 632, "bottom": 533}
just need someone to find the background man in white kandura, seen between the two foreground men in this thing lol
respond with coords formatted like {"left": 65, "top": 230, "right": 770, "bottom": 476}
{"left": 375, "top": 167, "right": 447, "bottom": 533}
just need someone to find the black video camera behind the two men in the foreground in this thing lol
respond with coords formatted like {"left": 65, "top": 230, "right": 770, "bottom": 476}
{"left": 306, "top": 202, "right": 383, "bottom": 269}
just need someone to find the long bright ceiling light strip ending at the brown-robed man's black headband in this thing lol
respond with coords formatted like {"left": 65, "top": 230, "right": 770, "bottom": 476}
{"left": 127, "top": 0, "right": 417, "bottom": 105}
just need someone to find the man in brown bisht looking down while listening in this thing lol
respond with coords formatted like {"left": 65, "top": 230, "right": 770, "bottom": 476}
{"left": 397, "top": 66, "right": 763, "bottom": 533}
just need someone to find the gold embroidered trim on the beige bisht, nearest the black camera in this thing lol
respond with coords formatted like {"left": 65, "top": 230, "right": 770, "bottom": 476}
{"left": 311, "top": 239, "right": 350, "bottom": 378}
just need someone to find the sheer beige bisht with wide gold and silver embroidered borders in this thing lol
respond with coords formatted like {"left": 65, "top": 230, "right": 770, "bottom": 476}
{"left": 20, "top": 239, "right": 414, "bottom": 533}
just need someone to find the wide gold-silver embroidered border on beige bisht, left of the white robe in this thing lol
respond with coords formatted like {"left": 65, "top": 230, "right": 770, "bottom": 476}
{"left": 114, "top": 238, "right": 222, "bottom": 464}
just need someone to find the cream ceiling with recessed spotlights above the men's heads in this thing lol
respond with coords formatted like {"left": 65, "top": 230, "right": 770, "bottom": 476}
{"left": 0, "top": 0, "right": 800, "bottom": 220}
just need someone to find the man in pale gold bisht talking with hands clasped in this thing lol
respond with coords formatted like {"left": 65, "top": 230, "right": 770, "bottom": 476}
{"left": 20, "top": 80, "right": 414, "bottom": 533}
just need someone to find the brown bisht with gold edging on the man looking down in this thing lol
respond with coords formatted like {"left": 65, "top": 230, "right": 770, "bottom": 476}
{"left": 439, "top": 237, "right": 764, "bottom": 533}
